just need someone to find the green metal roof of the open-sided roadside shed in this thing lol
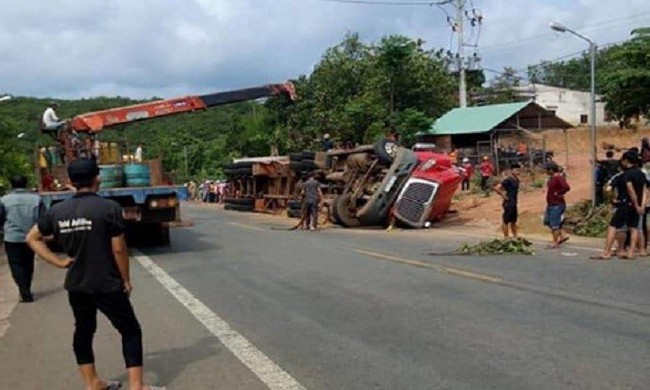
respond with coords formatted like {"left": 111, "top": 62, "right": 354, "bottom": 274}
{"left": 419, "top": 101, "right": 534, "bottom": 135}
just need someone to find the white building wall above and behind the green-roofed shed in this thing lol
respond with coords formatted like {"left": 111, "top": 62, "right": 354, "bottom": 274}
{"left": 518, "top": 84, "right": 616, "bottom": 126}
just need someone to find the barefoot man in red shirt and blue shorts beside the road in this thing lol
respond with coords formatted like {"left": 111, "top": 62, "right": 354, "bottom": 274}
{"left": 544, "top": 163, "right": 571, "bottom": 248}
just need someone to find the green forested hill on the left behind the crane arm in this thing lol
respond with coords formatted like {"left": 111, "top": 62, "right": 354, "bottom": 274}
{"left": 0, "top": 97, "right": 288, "bottom": 185}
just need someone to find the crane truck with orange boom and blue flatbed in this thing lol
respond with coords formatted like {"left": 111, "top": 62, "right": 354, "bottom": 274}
{"left": 37, "top": 82, "right": 296, "bottom": 245}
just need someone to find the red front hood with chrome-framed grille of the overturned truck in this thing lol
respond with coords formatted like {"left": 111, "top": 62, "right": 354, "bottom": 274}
{"left": 392, "top": 144, "right": 465, "bottom": 228}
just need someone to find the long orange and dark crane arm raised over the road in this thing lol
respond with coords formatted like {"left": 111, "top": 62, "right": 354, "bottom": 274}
{"left": 70, "top": 82, "right": 296, "bottom": 133}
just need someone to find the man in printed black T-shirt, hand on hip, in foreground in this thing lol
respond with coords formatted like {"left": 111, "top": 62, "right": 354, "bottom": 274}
{"left": 27, "top": 159, "right": 165, "bottom": 390}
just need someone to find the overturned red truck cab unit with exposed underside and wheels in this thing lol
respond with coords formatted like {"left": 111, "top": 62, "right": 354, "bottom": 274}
{"left": 326, "top": 140, "right": 464, "bottom": 228}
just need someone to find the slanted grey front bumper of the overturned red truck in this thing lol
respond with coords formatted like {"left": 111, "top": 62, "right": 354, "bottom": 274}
{"left": 357, "top": 148, "right": 418, "bottom": 225}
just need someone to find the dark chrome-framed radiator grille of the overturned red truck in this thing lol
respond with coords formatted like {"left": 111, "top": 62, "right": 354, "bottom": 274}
{"left": 393, "top": 178, "right": 440, "bottom": 228}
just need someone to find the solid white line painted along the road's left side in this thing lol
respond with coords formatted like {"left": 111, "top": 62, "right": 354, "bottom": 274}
{"left": 133, "top": 251, "right": 304, "bottom": 390}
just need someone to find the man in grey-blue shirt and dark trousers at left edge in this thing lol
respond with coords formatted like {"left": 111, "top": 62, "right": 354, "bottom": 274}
{"left": 0, "top": 175, "right": 44, "bottom": 302}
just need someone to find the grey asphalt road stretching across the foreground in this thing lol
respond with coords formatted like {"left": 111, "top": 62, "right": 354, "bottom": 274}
{"left": 0, "top": 205, "right": 650, "bottom": 389}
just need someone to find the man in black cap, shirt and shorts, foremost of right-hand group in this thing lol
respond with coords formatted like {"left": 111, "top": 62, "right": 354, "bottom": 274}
{"left": 591, "top": 151, "right": 646, "bottom": 260}
